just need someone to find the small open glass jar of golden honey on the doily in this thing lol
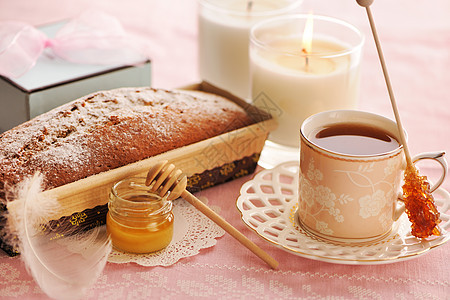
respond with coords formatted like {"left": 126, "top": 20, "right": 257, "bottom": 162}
{"left": 106, "top": 177, "right": 174, "bottom": 253}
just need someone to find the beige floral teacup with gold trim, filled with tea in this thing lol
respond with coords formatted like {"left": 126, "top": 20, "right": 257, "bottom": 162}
{"left": 298, "top": 110, "right": 447, "bottom": 243}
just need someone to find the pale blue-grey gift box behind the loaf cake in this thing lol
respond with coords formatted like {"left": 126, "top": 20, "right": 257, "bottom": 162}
{"left": 0, "top": 22, "right": 151, "bottom": 133}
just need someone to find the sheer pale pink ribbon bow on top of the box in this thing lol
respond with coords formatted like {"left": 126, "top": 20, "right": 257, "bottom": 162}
{"left": 0, "top": 11, "right": 147, "bottom": 78}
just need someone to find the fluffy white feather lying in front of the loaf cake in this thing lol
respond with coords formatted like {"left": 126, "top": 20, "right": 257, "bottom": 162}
{"left": 9, "top": 174, "right": 111, "bottom": 299}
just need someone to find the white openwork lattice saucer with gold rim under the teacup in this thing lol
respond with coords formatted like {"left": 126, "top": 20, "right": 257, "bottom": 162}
{"left": 236, "top": 162, "right": 450, "bottom": 265}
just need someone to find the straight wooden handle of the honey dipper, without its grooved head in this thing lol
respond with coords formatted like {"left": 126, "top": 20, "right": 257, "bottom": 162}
{"left": 181, "top": 190, "right": 278, "bottom": 269}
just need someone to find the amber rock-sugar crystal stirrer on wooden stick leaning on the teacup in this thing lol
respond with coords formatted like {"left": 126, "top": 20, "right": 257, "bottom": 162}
{"left": 356, "top": 0, "right": 447, "bottom": 238}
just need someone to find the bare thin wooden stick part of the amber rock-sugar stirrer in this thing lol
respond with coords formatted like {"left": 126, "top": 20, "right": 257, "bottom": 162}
{"left": 357, "top": 0, "right": 412, "bottom": 166}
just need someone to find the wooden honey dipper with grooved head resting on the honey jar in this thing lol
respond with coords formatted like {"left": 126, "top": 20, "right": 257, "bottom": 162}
{"left": 145, "top": 161, "right": 278, "bottom": 269}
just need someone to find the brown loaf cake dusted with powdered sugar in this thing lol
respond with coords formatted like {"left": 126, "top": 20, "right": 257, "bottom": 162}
{"left": 0, "top": 88, "right": 253, "bottom": 200}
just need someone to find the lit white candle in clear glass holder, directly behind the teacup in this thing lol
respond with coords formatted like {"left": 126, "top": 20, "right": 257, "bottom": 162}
{"left": 249, "top": 15, "right": 364, "bottom": 167}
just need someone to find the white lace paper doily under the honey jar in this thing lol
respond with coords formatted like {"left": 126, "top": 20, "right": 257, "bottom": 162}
{"left": 108, "top": 197, "right": 225, "bottom": 267}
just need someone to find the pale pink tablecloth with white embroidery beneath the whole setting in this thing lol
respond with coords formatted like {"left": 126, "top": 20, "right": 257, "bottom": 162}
{"left": 0, "top": 0, "right": 450, "bottom": 299}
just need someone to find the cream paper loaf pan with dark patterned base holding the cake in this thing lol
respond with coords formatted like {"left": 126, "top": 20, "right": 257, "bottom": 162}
{"left": 0, "top": 82, "right": 276, "bottom": 255}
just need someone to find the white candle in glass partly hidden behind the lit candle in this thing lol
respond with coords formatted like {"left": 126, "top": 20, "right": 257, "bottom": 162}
{"left": 198, "top": 0, "right": 302, "bottom": 99}
